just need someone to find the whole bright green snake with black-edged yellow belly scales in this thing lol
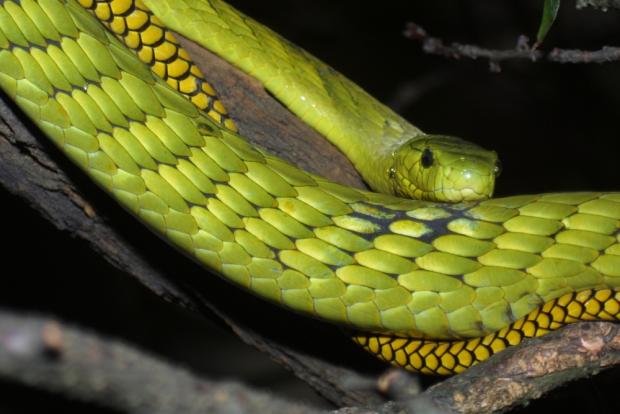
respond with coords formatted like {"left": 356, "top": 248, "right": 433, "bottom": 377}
{"left": 0, "top": 0, "right": 620, "bottom": 374}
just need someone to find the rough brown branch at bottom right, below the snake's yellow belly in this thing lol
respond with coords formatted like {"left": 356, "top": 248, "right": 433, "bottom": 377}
{"left": 416, "top": 322, "right": 620, "bottom": 414}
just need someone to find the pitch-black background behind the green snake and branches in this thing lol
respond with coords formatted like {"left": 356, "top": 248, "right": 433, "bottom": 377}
{"left": 0, "top": 0, "right": 620, "bottom": 413}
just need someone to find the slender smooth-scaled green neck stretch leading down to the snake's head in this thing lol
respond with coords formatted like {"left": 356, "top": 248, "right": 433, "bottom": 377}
{"left": 139, "top": 0, "right": 421, "bottom": 194}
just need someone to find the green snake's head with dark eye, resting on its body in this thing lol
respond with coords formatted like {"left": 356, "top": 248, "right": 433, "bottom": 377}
{"left": 389, "top": 135, "right": 501, "bottom": 202}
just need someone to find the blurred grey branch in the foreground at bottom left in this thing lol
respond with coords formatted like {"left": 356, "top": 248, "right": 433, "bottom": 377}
{"left": 0, "top": 311, "right": 318, "bottom": 414}
